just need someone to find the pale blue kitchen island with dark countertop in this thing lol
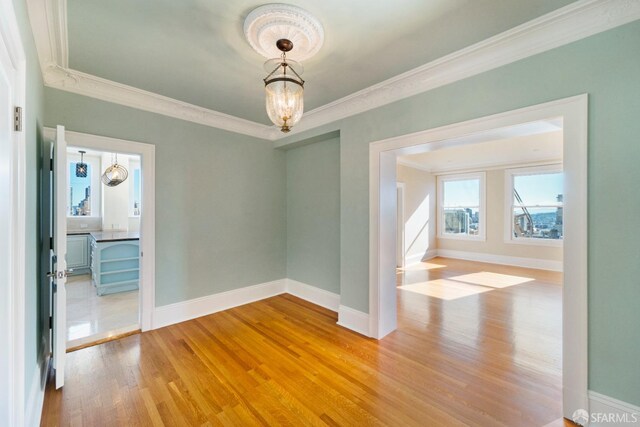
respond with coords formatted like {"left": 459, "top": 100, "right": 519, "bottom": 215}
{"left": 89, "top": 231, "right": 140, "bottom": 296}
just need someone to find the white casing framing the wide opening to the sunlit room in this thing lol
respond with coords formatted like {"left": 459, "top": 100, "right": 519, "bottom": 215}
{"left": 369, "top": 94, "right": 588, "bottom": 418}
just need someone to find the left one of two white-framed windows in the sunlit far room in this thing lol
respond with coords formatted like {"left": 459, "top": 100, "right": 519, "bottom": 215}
{"left": 438, "top": 172, "right": 486, "bottom": 240}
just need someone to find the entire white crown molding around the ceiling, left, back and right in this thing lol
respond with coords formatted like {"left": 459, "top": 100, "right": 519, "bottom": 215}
{"left": 26, "top": 0, "right": 640, "bottom": 142}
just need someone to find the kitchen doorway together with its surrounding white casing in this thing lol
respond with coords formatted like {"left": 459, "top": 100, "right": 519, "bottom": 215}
{"left": 45, "top": 126, "right": 155, "bottom": 362}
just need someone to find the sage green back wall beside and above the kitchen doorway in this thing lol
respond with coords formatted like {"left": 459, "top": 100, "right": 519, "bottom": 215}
{"left": 45, "top": 88, "right": 286, "bottom": 306}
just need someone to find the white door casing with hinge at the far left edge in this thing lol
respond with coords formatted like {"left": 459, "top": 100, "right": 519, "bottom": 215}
{"left": 0, "top": 1, "right": 26, "bottom": 425}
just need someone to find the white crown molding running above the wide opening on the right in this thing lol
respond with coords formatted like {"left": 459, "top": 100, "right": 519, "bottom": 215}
{"left": 282, "top": 0, "right": 640, "bottom": 139}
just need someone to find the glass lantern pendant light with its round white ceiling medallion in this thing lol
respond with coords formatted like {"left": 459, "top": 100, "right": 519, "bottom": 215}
{"left": 244, "top": 3, "right": 324, "bottom": 132}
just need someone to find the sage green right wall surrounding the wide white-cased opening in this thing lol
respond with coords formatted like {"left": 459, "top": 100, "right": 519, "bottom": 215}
{"left": 280, "top": 21, "right": 640, "bottom": 405}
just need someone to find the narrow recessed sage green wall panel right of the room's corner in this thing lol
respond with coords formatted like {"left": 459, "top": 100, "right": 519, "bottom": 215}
{"left": 287, "top": 138, "right": 340, "bottom": 294}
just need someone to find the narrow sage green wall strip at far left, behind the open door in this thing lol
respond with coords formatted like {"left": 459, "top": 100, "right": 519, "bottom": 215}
{"left": 13, "top": 0, "right": 48, "bottom": 403}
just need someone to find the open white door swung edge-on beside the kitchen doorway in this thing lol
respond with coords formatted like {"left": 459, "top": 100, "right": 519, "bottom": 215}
{"left": 52, "top": 126, "right": 68, "bottom": 388}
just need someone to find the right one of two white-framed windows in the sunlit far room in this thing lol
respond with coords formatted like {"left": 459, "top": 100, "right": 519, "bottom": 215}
{"left": 505, "top": 165, "right": 564, "bottom": 245}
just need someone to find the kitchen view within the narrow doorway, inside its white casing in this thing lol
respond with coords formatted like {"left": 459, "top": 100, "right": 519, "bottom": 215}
{"left": 66, "top": 146, "right": 143, "bottom": 351}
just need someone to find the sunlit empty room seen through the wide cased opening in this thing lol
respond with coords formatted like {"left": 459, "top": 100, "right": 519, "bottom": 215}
{"left": 397, "top": 120, "right": 571, "bottom": 425}
